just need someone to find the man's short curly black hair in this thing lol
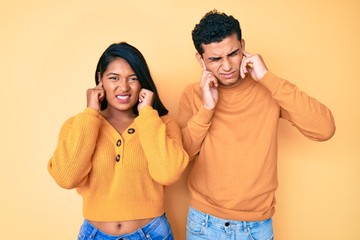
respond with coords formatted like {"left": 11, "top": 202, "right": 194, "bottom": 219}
{"left": 192, "top": 9, "right": 241, "bottom": 55}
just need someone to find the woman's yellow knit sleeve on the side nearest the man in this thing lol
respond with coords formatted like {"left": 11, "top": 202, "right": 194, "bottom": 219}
{"left": 135, "top": 106, "right": 189, "bottom": 185}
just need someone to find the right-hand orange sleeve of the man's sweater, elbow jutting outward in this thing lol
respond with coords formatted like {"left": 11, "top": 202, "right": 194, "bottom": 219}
{"left": 259, "top": 72, "right": 335, "bottom": 141}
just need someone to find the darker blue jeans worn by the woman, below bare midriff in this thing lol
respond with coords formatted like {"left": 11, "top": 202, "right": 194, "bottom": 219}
{"left": 78, "top": 214, "right": 174, "bottom": 240}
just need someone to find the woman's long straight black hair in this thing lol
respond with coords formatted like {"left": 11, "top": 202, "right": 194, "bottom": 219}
{"left": 95, "top": 42, "right": 169, "bottom": 116}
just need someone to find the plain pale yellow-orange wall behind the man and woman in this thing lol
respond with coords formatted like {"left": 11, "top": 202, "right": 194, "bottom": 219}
{"left": 0, "top": 0, "right": 360, "bottom": 240}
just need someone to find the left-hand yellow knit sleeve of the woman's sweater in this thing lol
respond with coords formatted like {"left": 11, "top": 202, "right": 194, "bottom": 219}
{"left": 48, "top": 108, "right": 101, "bottom": 189}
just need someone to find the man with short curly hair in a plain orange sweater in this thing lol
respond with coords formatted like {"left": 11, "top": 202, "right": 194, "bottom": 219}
{"left": 179, "top": 10, "right": 335, "bottom": 240}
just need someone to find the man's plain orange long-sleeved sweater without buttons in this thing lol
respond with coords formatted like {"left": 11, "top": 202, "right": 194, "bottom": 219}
{"left": 179, "top": 72, "right": 335, "bottom": 221}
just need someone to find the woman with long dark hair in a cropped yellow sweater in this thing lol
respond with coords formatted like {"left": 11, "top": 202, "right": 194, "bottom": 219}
{"left": 48, "top": 42, "right": 188, "bottom": 240}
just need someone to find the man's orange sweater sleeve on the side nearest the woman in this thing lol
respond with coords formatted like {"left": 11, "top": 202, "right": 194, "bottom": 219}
{"left": 178, "top": 85, "right": 214, "bottom": 160}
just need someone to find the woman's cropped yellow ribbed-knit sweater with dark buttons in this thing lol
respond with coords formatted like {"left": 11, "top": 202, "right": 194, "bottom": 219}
{"left": 48, "top": 107, "right": 188, "bottom": 221}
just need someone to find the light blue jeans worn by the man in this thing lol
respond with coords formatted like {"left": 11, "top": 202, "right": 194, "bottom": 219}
{"left": 186, "top": 207, "right": 274, "bottom": 240}
